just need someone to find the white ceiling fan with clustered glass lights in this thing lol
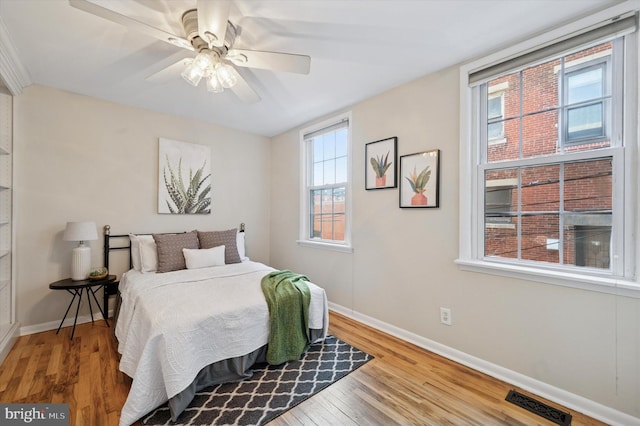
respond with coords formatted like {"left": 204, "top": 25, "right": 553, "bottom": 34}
{"left": 69, "top": 0, "right": 311, "bottom": 103}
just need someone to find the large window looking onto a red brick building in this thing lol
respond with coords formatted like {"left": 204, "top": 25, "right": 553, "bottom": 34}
{"left": 459, "top": 10, "right": 638, "bottom": 296}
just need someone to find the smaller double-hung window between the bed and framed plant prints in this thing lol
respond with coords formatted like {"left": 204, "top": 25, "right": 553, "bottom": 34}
{"left": 301, "top": 116, "right": 350, "bottom": 251}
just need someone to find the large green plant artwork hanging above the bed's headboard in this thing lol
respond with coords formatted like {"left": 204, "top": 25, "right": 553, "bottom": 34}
{"left": 158, "top": 138, "right": 211, "bottom": 214}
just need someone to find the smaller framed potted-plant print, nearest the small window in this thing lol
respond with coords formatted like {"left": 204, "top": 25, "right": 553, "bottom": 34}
{"left": 365, "top": 136, "right": 398, "bottom": 189}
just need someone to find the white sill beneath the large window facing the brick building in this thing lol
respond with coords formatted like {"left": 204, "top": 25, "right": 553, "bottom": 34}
{"left": 455, "top": 259, "right": 640, "bottom": 299}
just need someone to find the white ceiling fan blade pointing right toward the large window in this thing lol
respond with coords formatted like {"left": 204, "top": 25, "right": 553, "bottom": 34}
{"left": 225, "top": 49, "right": 311, "bottom": 74}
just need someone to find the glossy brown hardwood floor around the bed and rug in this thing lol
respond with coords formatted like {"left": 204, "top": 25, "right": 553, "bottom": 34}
{"left": 0, "top": 312, "right": 603, "bottom": 426}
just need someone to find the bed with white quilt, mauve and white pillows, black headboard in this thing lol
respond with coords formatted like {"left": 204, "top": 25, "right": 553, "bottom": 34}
{"left": 105, "top": 227, "right": 328, "bottom": 426}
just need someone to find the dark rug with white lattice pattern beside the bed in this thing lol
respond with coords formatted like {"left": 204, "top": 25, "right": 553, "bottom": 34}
{"left": 142, "top": 336, "right": 373, "bottom": 425}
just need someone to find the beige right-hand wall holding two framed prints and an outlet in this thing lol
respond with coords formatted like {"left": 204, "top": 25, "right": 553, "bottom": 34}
{"left": 270, "top": 67, "right": 640, "bottom": 417}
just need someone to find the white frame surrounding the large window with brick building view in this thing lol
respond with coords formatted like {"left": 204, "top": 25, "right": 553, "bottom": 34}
{"left": 455, "top": 7, "right": 640, "bottom": 298}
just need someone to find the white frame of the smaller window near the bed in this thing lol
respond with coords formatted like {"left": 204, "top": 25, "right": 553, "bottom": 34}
{"left": 297, "top": 112, "right": 353, "bottom": 253}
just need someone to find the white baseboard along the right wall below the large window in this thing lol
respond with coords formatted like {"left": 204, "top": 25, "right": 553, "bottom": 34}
{"left": 329, "top": 302, "right": 640, "bottom": 426}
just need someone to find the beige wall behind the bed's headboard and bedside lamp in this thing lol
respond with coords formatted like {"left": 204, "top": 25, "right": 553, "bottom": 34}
{"left": 14, "top": 86, "right": 270, "bottom": 327}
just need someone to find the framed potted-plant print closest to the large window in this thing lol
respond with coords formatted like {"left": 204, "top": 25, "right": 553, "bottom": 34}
{"left": 400, "top": 149, "right": 440, "bottom": 208}
